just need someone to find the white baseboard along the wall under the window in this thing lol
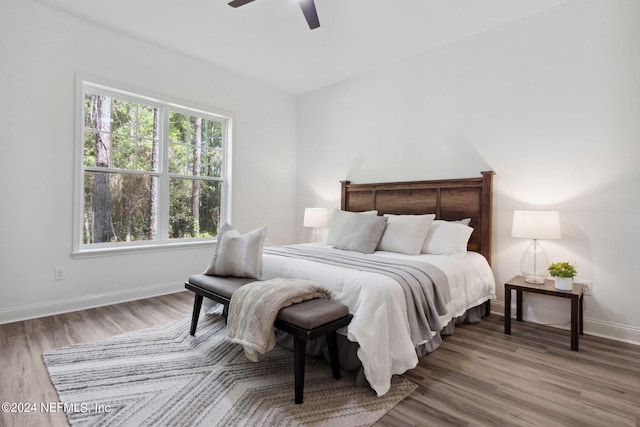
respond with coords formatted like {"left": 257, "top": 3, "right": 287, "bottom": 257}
{"left": 0, "top": 283, "right": 184, "bottom": 325}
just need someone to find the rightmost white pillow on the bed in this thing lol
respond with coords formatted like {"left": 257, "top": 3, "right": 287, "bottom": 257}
{"left": 422, "top": 220, "right": 473, "bottom": 255}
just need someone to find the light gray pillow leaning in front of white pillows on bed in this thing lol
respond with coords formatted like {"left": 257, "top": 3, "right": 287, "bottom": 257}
{"left": 333, "top": 215, "right": 387, "bottom": 254}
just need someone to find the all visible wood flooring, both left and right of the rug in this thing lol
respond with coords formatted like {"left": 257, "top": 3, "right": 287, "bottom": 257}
{"left": 0, "top": 292, "right": 640, "bottom": 427}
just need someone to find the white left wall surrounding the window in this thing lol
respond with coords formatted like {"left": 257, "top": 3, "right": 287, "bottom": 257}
{"left": 0, "top": 0, "right": 296, "bottom": 323}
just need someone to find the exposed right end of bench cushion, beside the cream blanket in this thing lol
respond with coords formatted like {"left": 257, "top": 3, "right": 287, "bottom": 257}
{"left": 278, "top": 298, "right": 349, "bottom": 331}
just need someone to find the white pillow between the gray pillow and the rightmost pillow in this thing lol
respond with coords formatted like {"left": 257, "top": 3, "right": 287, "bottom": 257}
{"left": 378, "top": 214, "right": 436, "bottom": 255}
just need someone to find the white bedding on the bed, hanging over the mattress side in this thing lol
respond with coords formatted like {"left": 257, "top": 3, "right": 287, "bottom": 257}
{"left": 262, "top": 244, "right": 495, "bottom": 396}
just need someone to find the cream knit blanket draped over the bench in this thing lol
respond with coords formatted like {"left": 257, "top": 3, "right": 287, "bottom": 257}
{"left": 227, "top": 278, "right": 330, "bottom": 362}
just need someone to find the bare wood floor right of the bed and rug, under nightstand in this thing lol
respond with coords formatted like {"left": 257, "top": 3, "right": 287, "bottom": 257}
{"left": 376, "top": 314, "right": 640, "bottom": 426}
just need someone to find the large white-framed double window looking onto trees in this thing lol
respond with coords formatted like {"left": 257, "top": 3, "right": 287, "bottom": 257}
{"left": 75, "top": 82, "right": 230, "bottom": 252}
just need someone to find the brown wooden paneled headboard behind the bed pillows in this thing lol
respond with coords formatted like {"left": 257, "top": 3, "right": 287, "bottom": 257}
{"left": 340, "top": 171, "right": 494, "bottom": 264}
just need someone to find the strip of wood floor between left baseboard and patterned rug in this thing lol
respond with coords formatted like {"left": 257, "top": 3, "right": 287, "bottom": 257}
{"left": 0, "top": 291, "right": 193, "bottom": 427}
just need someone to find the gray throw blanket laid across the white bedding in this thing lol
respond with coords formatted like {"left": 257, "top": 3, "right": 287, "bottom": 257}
{"left": 264, "top": 246, "right": 451, "bottom": 346}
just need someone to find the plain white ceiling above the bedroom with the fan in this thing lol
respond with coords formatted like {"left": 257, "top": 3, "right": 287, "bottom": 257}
{"left": 38, "top": 0, "right": 570, "bottom": 94}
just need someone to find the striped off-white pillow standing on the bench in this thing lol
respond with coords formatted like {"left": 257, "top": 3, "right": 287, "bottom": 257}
{"left": 204, "top": 223, "right": 267, "bottom": 280}
